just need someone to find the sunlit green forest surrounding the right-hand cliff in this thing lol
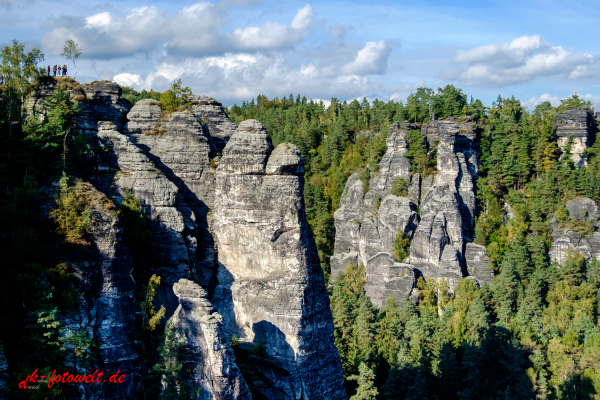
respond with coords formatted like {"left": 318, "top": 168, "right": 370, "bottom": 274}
{"left": 229, "top": 92, "right": 600, "bottom": 399}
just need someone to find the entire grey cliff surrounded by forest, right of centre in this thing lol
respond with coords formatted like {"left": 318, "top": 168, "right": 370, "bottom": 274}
{"left": 331, "top": 121, "right": 492, "bottom": 306}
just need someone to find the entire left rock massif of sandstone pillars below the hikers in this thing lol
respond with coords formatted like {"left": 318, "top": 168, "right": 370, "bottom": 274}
{"left": 28, "top": 82, "right": 345, "bottom": 399}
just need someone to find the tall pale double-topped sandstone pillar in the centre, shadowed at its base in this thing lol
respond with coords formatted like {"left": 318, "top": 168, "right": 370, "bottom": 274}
{"left": 211, "top": 120, "right": 346, "bottom": 399}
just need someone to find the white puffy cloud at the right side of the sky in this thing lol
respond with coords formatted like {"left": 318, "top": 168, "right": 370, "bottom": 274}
{"left": 446, "top": 35, "right": 600, "bottom": 87}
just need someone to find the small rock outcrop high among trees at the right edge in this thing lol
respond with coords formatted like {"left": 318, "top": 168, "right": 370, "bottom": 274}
{"left": 556, "top": 107, "right": 597, "bottom": 168}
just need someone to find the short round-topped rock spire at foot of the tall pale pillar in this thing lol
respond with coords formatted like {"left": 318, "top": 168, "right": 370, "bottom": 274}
{"left": 167, "top": 279, "right": 252, "bottom": 400}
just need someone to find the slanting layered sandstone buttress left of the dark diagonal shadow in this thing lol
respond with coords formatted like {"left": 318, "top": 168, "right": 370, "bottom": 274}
{"left": 96, "top": 122, "right": 198, "bottom": 315}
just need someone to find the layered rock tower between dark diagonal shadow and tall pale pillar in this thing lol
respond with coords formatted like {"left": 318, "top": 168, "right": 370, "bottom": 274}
{"left": 126, "top": 100, "right": 216, "bottom": 300}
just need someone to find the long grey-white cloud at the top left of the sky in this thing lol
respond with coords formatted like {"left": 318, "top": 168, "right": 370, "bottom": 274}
{"left": 43, "top": 2, "right": 315, "bottom": 59}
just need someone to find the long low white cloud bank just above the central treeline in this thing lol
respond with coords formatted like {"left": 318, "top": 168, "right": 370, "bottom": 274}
{"left": 123, "top": 53, "right": 380, "bottom": 103}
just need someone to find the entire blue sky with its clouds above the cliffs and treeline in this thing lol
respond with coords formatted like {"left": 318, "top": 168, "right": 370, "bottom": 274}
{"left": 0, "top": 0, "right": 600, "bottom": 107}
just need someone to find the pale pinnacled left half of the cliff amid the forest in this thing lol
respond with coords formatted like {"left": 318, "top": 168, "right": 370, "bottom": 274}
{"left": 330, "top": 123, "right": 419, "bottom": 290}
